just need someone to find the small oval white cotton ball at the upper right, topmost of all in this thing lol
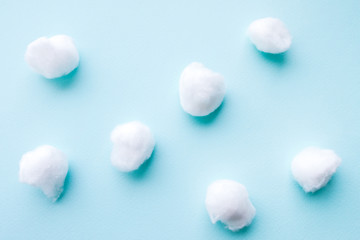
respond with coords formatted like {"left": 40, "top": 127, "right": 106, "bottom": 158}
{"left": 248, "top": 18, "right": 291, "bottom": 54}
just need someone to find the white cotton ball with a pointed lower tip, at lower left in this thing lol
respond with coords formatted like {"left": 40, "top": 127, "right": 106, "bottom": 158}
{"left": 19, "top": 145, "right": 68, "bottom": 201}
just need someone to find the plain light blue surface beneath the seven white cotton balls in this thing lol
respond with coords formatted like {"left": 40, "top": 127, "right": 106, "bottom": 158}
{"left": 0, "top": 0, "right": 360, "bottom": 240}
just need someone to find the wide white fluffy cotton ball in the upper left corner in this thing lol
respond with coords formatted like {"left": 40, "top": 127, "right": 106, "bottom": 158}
{"left": 25, "top": 35, "right": 79, "bottom": 79}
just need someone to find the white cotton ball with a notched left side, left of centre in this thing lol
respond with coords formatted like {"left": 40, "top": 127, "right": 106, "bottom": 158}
{"left": 111, "top": 121, "right": 155, "bottom": 172}
